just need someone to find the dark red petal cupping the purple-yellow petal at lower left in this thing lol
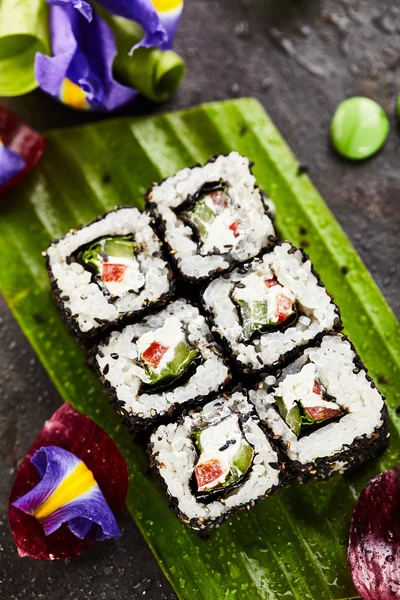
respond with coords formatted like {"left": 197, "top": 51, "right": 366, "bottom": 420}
{"left": 8, "top": 403, "right": 129, "bottom": 560}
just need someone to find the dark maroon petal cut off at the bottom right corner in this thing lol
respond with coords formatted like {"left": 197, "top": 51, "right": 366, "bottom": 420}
{"left": 347, "top": 465, "right": 400, "bottom": 600}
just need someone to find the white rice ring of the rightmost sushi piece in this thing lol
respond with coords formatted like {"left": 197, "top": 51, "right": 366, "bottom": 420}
{"left": 250, "top": 335, "right": 383, "bottom": 471}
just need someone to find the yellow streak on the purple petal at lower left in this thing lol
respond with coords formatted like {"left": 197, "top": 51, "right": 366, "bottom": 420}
{"left": 33, "top": 462, "right": 96, "bottom": 520}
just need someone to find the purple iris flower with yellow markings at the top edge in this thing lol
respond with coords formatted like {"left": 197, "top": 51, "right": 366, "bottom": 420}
{"left": 35, "top": 0, "right": 182, "bottom": 110}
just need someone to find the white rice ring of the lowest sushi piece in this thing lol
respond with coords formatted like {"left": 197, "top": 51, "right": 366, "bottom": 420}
{"left": 150, "top": 392, "right": 279, "bottom": 528}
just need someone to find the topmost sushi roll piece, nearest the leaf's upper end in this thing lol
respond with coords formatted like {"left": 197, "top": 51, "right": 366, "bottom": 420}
{"left": 147, "top": 152, "right": 275, "bottom": 281}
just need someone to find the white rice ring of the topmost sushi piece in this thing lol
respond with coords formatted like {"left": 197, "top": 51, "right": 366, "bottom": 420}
{"left": 149, "top": 152, "right": 275, "bottom": 279}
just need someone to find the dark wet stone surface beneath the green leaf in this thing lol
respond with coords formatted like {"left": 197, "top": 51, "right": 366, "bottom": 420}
{"left": 0, "top": 0, "right": 400, "bottom": 600}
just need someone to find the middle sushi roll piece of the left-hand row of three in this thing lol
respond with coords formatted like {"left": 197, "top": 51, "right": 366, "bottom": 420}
{"left": 92, "top": 300, "right": 230, "bottom": 432}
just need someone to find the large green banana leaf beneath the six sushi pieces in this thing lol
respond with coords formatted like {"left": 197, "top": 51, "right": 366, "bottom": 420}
{"left": 0, "top": 99, "right": 400, "bottom": 600}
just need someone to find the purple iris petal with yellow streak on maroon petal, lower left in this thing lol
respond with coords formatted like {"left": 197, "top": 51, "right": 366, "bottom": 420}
{"left": 13, "top": 446, "right": 120, "bottom": 540}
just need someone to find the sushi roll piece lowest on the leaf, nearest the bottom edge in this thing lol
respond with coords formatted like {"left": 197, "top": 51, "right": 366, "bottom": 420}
{"left": 149, "top": 391, "right": 285, "bottom": 530}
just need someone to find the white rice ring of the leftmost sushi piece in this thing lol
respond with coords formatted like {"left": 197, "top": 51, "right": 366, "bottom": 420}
{"left": 47, "top": 208, "right": 170, "bottom": 333}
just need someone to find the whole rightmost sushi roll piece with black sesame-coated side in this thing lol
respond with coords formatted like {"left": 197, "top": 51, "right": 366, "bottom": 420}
{"left": 250, "top": 334, "right": 388, "bottom": 480}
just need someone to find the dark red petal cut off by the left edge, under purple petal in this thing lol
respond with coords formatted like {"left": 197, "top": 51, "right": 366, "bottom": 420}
{"left": 0, "top": 104, "right": 46, "bottom": 195}
